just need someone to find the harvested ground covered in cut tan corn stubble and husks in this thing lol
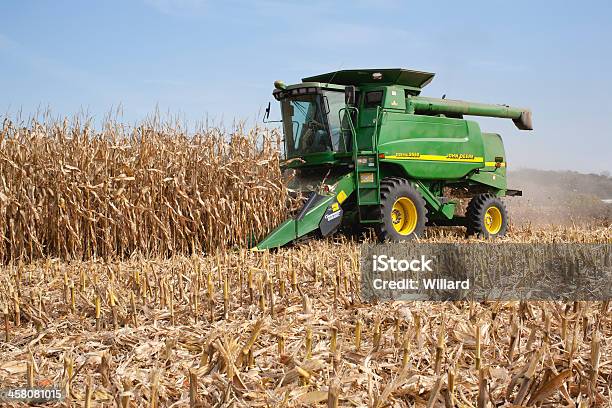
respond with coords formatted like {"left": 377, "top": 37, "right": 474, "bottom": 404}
{"left": 0, "top": 228, "right": 612, "bottom": 407}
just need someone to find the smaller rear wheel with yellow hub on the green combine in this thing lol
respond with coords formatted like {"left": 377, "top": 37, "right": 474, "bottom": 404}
{"left": 465, "top": 194, "right": 508, "bottom": 238}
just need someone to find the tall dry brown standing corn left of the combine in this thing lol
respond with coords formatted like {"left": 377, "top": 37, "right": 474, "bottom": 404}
{"left": 0, "top": 118, "right": 287, "bottom": 262}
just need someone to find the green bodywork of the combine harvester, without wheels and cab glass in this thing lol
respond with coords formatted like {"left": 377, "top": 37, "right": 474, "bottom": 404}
{"left": 256, "top": 69, "right": 532, "bottom": 249}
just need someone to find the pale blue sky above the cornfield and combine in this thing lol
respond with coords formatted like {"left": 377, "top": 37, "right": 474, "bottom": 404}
{"left": 0, "top": 0, "right": 612, "bottom": 173}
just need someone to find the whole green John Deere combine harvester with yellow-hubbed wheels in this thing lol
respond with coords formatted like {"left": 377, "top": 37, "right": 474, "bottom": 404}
{"left": 253, "top": 69, "right": 532, "bottom": 250}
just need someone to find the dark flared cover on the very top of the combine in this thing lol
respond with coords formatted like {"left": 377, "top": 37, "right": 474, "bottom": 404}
{"left": 302, "top": 68, "right": 435, "bottom": 90}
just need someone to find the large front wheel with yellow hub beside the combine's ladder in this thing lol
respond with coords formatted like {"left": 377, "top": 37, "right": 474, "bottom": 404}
{"left": 376, "top": 177, "right": 427, "bottom": 242}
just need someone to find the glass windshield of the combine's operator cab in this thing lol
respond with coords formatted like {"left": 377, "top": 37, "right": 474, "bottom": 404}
{"left": 281, "top": 91, "right": 350, "bottom": 158}
